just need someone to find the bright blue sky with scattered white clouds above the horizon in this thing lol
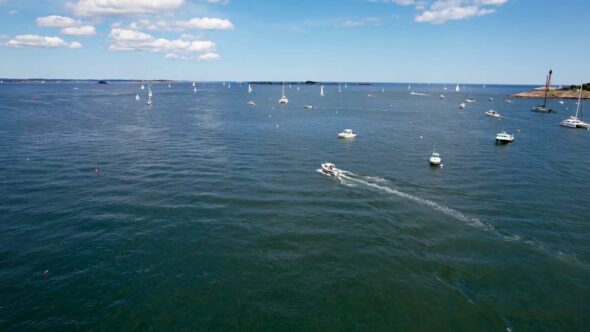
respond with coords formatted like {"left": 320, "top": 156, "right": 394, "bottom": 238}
{"left": 0, "top": 0, "right": 590, "bottom": 84}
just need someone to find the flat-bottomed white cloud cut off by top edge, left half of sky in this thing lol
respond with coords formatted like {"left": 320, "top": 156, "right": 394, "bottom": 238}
{"left": 66, "top": 0, "right": 184, "bottom": 16}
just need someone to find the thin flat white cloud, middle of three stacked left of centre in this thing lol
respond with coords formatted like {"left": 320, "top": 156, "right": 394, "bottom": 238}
{"left": 123, "top": 17, "right": 234, "bottom": 31}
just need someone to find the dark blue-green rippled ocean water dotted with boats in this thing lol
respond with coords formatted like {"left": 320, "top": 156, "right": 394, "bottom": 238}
{"left": 0, "top": 83, "right": 590, "bottom": 331}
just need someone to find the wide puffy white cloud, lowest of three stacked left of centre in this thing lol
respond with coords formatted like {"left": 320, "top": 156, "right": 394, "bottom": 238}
{"left": 109, "top": 28, "right": 215, "bottom": 54}
